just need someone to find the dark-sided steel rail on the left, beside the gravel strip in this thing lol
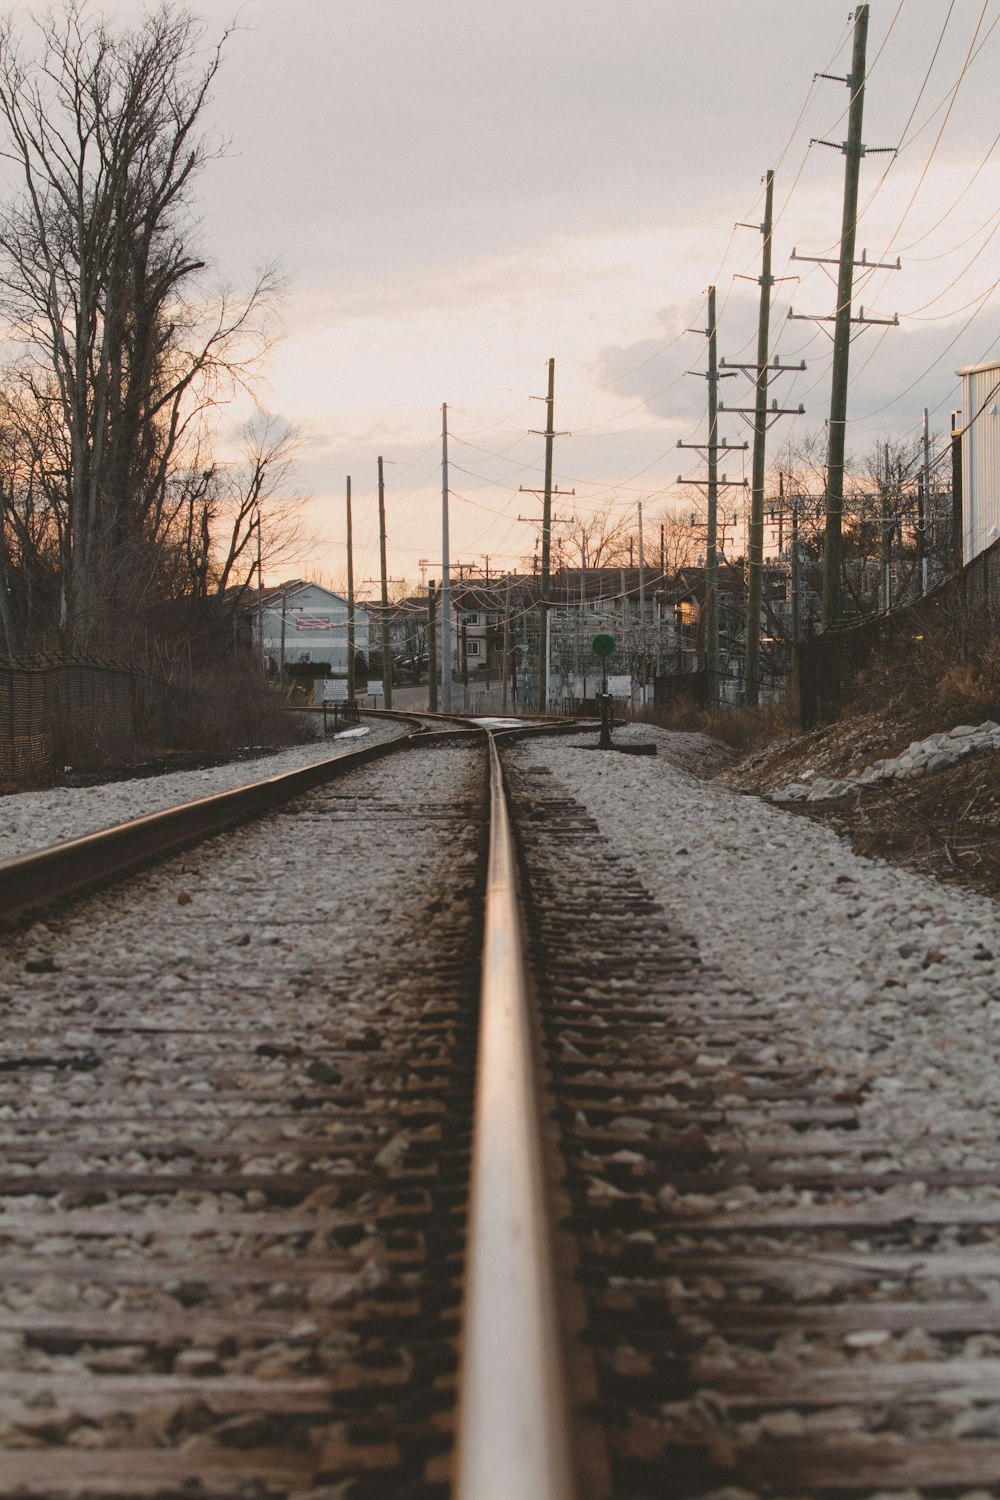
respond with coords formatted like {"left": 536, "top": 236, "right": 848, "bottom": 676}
{"left": 0, "top": 726, "right": 427, "bottom": 926}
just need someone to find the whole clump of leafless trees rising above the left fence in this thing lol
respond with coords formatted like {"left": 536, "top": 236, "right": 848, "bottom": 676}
{"left": 0, "top": 0, "right": 294, "bottom": 650}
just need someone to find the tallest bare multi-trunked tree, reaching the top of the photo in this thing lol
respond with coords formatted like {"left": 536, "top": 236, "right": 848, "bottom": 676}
{"left": 0, "top": 0, "right": 276, "bottom": 645}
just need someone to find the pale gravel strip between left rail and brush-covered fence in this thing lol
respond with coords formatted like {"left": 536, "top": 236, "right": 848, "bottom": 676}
{"left": 0, "top": 716, "right": 406, "bottom": 860}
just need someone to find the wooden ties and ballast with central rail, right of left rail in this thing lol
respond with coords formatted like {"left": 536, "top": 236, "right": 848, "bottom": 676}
{"left": 0, "top": 731, "right": 1000, "bottom": 1500}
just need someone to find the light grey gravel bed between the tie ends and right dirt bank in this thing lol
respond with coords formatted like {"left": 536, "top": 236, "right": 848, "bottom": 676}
{"left": 514, "top": 725, "right": 1000, "bottom": 1169}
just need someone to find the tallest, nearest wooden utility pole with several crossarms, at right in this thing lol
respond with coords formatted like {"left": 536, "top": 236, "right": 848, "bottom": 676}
{"left": 789, "top": 3, "right": 900, "bottom": 630}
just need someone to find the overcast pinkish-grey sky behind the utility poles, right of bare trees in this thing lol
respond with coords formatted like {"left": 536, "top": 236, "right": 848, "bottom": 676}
{"left": 18, "top": 0, "right": 1000, "bottom": 579}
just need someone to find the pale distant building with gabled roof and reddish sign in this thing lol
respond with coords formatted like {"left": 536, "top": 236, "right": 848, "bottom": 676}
{"left": 246, "top": 579, "right": 369, "bottom": 677}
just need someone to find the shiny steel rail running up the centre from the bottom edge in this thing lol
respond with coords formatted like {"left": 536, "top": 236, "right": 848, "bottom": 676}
{"left": 456, "top": 735, "right": 576, "bottom": 1500}
